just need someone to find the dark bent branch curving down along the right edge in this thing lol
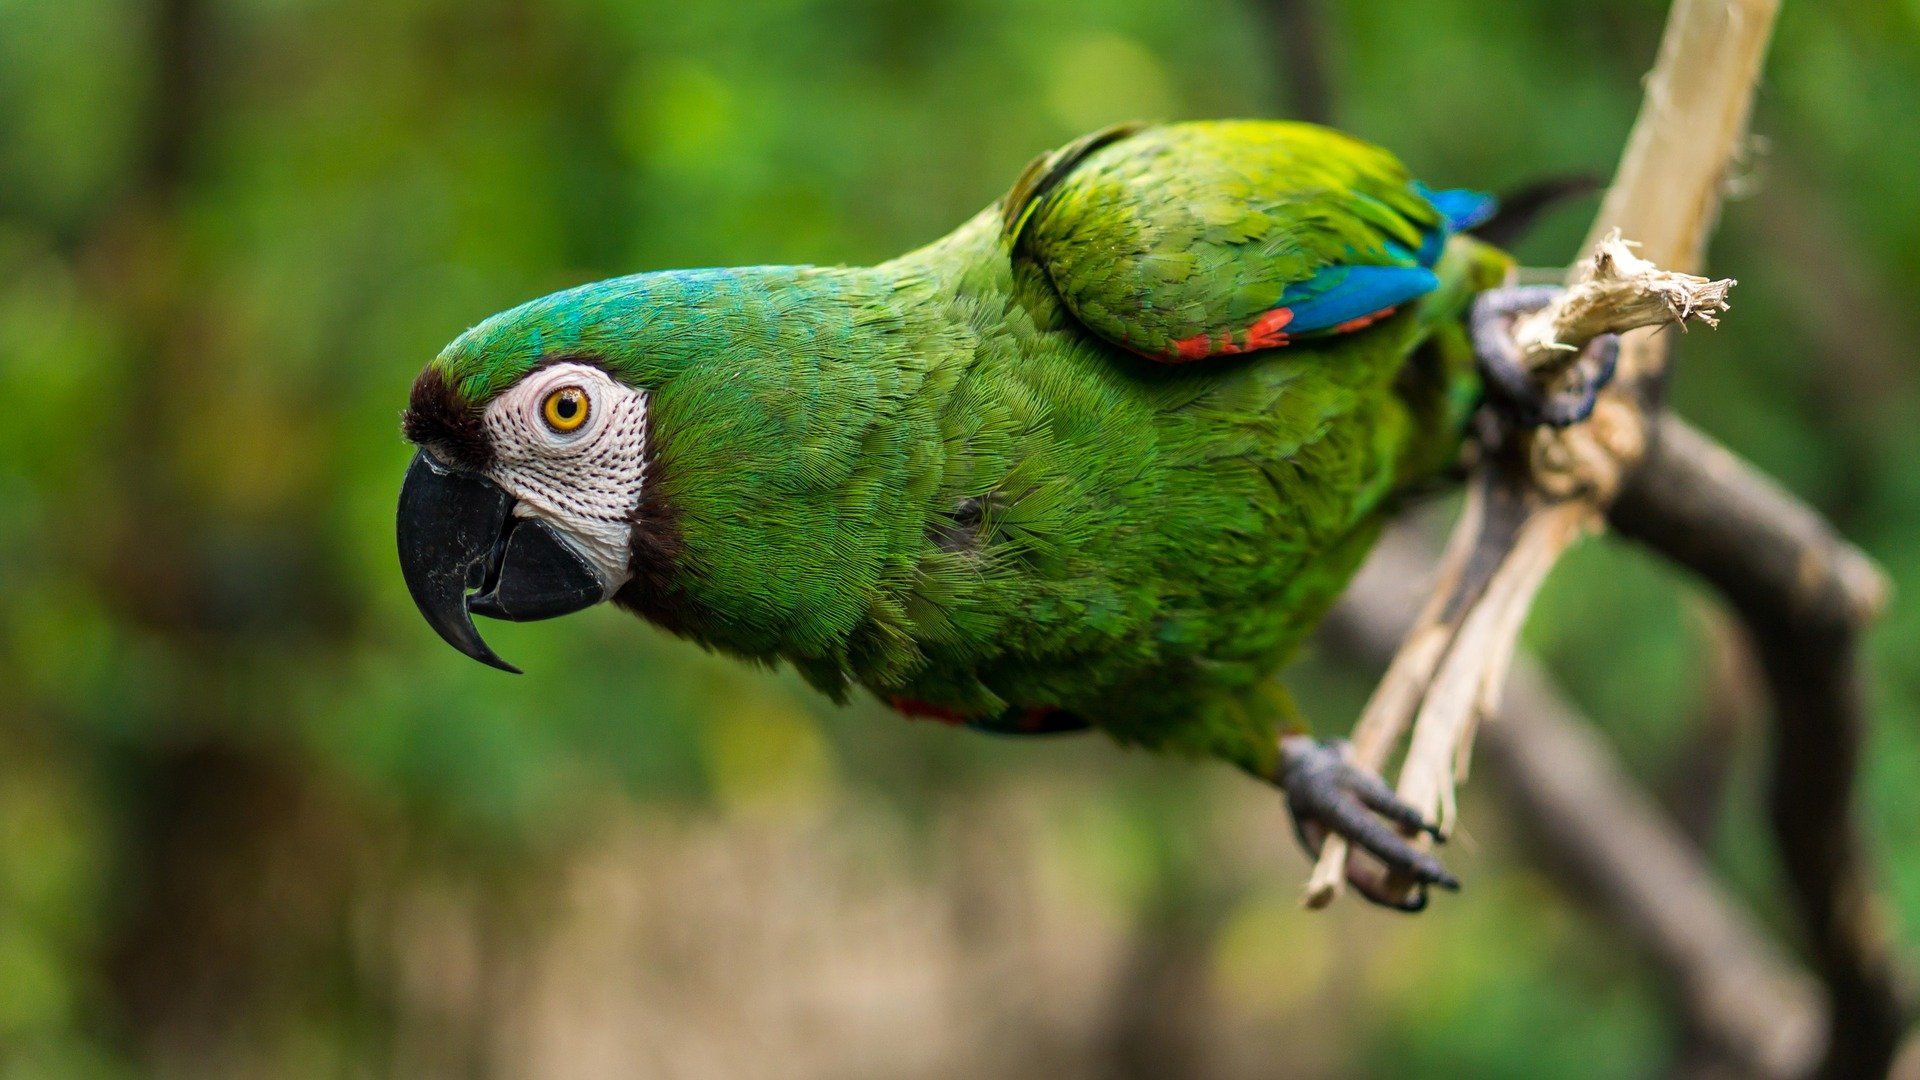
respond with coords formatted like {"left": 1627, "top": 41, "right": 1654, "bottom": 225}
{"left": 1611, "top": 417, "right": 1912, "bottom": 1076}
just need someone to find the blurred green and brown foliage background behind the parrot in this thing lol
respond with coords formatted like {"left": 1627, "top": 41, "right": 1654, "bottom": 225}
{"left": 0, "top": 0, "right": 1920, "bottom": 1080}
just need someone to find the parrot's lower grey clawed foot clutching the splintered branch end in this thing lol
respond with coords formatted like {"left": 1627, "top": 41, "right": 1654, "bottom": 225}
{"left": 1279, "top": 734, "right": 1459, "bottom": 911}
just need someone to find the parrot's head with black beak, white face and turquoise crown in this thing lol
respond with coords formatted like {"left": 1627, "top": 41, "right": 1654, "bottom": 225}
{"left": 397, "top": 279, "right": 683, "bottom": 673}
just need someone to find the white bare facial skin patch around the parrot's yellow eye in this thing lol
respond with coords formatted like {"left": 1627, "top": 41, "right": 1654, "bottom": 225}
{"left": 486, "top": 363, "right": 647, "bottom": 596}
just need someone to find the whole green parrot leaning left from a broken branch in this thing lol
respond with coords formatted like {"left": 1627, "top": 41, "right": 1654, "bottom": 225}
{"left": 397, "top": 119, "right": 1611, "bottom": 911}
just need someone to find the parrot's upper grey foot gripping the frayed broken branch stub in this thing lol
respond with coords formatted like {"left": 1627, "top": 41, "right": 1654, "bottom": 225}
{"left": 1473, "top": 284, "right": 1620, "bottom": 429}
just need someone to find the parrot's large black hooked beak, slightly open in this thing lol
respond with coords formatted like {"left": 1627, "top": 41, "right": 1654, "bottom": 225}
{"left": 399, "top": 450, "right": 607, "bottom": 675}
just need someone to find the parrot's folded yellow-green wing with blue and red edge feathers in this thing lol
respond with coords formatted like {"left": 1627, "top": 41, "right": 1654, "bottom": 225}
{"left": 1004, "top": 121, "right": 1492, "bottom": 363}
